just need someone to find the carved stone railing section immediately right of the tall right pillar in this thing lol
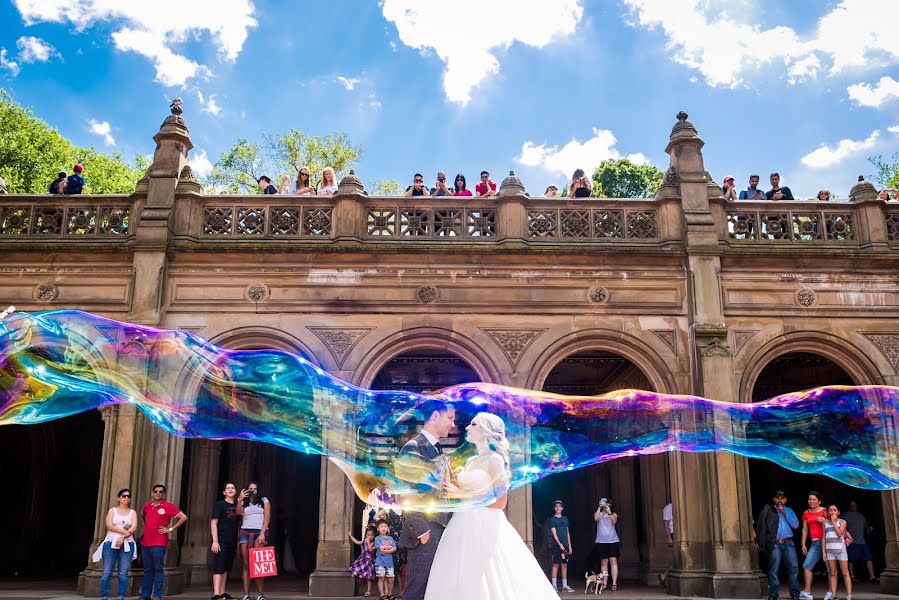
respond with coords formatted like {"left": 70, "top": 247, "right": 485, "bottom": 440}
{"left": 724, "top": 201, "right": 859, "bottom": 243}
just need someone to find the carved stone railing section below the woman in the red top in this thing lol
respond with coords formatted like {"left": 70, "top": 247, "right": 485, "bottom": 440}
{"left": 365, "top": 197, "right": 497, "bottom": 241}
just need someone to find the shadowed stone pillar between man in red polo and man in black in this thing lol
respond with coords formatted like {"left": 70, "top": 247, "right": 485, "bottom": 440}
{"left": 181, "top": 440, "right": 222, "bottom": 585}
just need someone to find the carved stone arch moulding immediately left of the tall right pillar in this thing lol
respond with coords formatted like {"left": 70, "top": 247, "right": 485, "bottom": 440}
{"left": 526, "top": 329, "right": 678, "bottom": 394}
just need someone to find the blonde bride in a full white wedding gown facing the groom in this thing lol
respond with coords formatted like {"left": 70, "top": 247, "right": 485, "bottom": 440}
{"left": 425, "top": 413, "right": 559, "bottom": 600}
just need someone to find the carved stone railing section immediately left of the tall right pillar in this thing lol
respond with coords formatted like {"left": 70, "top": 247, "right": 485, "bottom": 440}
{"left": 527, "top": 198, "right": 659, "bottom": 241}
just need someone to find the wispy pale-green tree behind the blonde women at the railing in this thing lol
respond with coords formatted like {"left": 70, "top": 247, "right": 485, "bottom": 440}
{"left": 264, "top": 129, "right": 364, "bottom": 184}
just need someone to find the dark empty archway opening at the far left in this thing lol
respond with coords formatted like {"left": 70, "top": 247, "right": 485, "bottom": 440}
{"left": 0, "top": 410, "right": 104, "bottom": 582}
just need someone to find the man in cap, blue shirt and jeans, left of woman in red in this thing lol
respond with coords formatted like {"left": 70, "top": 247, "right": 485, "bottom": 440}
{"left": 756, "top": 490, "right": 799, "bottom": 600}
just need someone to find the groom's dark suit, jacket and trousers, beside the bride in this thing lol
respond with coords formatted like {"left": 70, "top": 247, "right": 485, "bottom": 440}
{"left": 398, "top": 434, "right": 452, "bottom": 600}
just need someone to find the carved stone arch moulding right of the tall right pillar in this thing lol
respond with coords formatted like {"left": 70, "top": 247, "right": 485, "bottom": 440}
{"left": 740, "top": 331, "right": 883, "bottom": 403}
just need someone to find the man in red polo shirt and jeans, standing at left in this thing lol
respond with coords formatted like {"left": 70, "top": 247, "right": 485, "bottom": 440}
{"left": 140, "top": 483, "right": 187, "bottom": 600}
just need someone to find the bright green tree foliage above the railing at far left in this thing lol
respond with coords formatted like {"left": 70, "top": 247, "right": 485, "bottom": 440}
{"left": 0, "top": 89, "right": 147, "bottom": 194}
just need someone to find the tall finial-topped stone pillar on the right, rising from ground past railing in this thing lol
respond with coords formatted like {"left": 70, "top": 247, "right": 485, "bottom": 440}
{"left": 666, "top": 112, "right": 761, "bottom": 598}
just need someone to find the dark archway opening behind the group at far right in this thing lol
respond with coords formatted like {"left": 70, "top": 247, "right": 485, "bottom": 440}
{"left": 748, "top": 351, "right": 885, "bottom": 575}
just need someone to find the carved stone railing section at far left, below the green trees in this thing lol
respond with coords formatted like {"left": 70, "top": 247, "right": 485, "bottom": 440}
{"left": 0, "top": 195, "right": 140, "bottom": 240}
